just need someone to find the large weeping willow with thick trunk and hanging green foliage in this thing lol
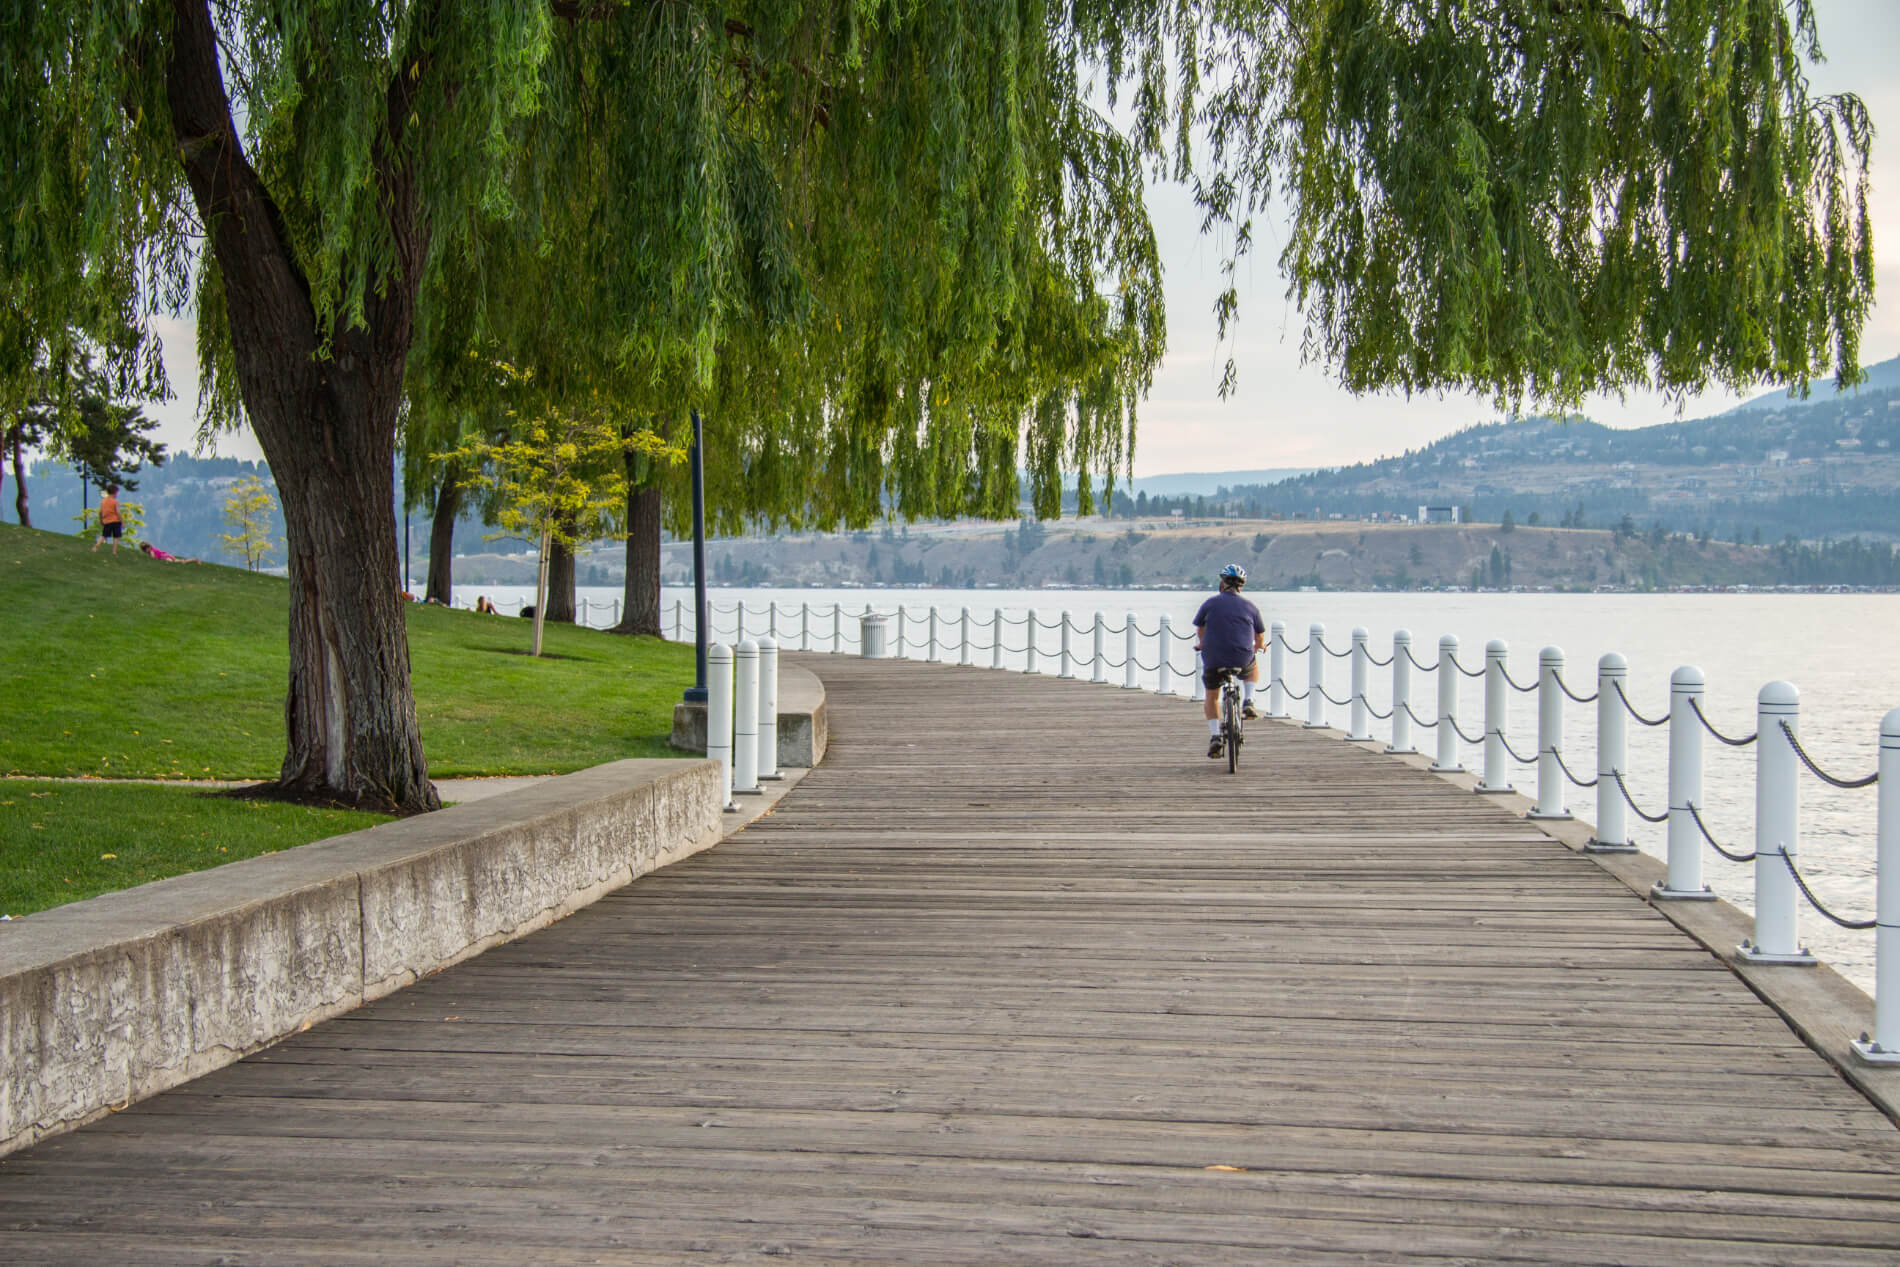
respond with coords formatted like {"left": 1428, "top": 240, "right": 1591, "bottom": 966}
{"left": 0, "top": 0, "right": 1872, "bottom": 809}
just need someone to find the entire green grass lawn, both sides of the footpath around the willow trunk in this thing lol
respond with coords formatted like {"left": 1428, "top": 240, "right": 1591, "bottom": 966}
{"left": 0, "top": 524, "right": 694, "bottom": 916}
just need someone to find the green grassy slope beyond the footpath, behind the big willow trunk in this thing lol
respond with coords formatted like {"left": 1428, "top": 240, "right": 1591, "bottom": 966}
{"left": 0, "top": 524, "right": 692, "bottom": 779}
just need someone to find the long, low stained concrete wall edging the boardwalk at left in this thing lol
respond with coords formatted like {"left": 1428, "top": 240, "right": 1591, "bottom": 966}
{"left": 0, "top": 760, "right": 720, "bottom": 1153}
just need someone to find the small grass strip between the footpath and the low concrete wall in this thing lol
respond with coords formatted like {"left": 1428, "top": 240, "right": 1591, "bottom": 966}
{"left": 0, "top": 779, "right": 388, "bottom": 916}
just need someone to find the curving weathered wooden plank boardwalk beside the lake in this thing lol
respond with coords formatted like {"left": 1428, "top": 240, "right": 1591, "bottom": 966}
{"left": 0, "top": 657, "right": 1900, "bottom": 1265}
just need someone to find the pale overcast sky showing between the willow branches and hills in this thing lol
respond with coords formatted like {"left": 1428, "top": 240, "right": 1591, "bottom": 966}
{"left": 148, "top": 0, "right": 1900, "bottom": 475}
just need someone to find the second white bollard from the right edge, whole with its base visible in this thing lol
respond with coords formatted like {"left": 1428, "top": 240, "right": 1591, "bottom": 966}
{"left": 1737, "top": 682, "right": 1815, "bottom": 965}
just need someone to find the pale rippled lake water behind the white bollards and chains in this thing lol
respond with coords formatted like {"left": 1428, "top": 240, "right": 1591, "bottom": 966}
{"left": 466, "top": 587, "right": 1900, "bottom": 992}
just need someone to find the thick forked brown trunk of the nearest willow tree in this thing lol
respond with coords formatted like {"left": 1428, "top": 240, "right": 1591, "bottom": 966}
{"left": 165, "top": 0, "right": 441, "bottom": 813}
